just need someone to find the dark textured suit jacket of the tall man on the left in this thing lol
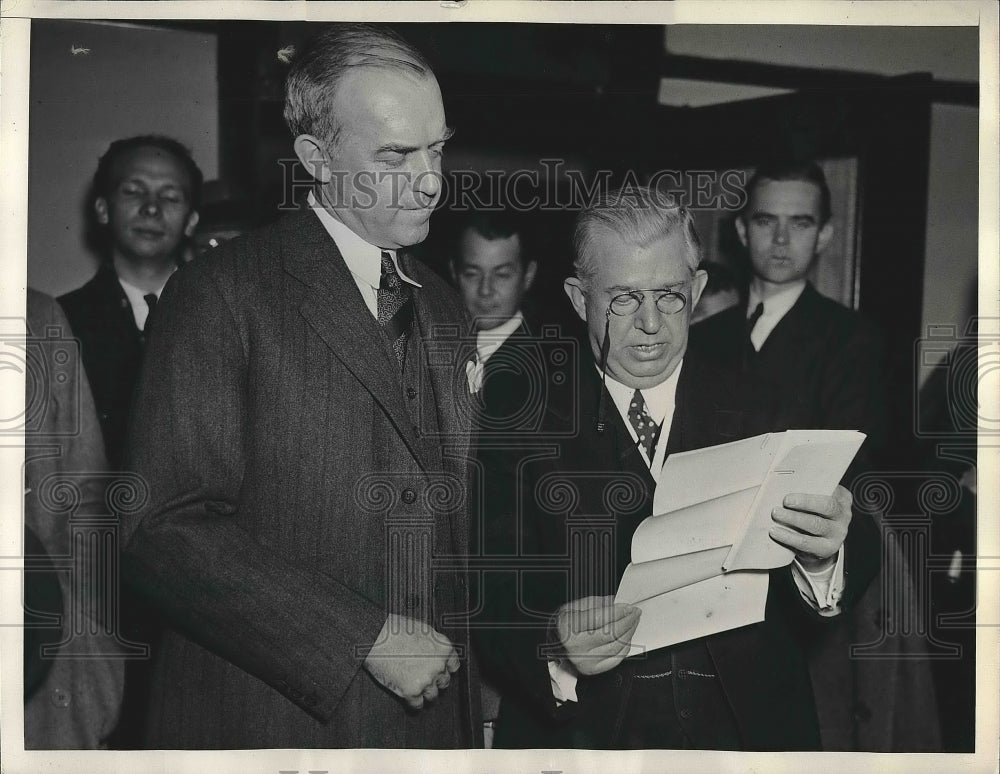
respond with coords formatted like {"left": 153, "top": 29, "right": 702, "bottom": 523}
{"left": 123, "top": 211, "right": 478, "bottom": 748}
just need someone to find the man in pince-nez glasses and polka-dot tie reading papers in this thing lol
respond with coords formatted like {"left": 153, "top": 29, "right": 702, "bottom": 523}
{"left": 474, "top": 188, "right": 877, "bottom": 750}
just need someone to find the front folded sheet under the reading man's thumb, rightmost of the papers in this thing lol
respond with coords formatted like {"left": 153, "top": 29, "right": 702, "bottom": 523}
{"left": 723, "top": 430, "right": 865, "bottom": 571}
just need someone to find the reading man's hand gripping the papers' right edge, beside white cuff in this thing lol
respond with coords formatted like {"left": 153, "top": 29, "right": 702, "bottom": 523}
{"left": 768, "top": 486, "right": 854, "bottom": 569}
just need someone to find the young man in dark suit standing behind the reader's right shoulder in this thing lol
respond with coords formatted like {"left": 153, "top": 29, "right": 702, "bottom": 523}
{"left": 691, "top": 162, "right": 885, "bottom": 470}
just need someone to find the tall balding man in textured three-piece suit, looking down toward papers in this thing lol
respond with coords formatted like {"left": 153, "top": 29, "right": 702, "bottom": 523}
{"left": 117, "top": 25, "right": 478, "bottom": 748}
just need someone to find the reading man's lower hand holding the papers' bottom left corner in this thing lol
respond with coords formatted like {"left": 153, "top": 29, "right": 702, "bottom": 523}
{"left": 555, "top": 596, "right": 642, "bottom": 675}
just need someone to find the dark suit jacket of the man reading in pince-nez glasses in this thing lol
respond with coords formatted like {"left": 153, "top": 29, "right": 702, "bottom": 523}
{"left": 473, "top": 359, "right": 877, "bottom": 750}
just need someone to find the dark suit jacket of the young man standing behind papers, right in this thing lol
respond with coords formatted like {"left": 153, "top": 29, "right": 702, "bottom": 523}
{"left": 688, "top": 284, "right": 885, "bottom": 474}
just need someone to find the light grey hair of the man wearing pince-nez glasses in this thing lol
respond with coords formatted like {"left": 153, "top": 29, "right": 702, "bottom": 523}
{"left": 573, "top": 185, "right": 701, "bottom": 281}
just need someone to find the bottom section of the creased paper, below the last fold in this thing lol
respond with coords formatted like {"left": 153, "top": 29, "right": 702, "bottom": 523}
{"left": 629, "top": 570, "right": 768, "bottom": 656}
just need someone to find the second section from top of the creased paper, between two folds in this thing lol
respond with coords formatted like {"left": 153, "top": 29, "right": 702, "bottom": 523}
{"left": 632, "top": 487, "right": 757, "bottom": 569}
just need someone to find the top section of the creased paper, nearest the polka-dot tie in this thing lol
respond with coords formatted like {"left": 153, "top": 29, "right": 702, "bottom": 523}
{"left": 653, "top": 433, "right": 784, "bottom": 513}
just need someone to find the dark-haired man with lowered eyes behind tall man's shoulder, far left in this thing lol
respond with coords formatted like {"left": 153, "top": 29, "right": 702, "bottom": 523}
{"left": 59, "top": 136, "right": 202, "bottom": 470}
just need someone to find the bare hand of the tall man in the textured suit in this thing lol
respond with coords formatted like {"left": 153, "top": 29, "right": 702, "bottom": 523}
{"left": 364, "top": 613, "right": 460, "bottom": 709}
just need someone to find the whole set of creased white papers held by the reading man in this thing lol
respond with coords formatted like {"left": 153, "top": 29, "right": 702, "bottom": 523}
{"left": 615, "top": 430, "right": 865, "bottom": 655}
